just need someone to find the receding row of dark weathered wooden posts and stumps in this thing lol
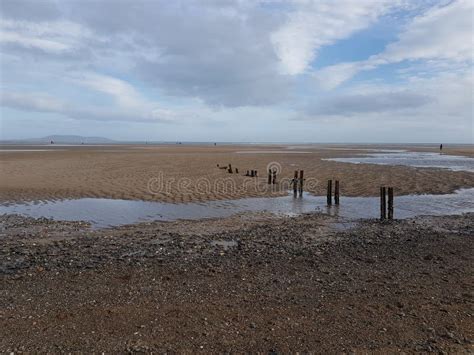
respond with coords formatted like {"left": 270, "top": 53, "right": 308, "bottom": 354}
{"left": 217, "top": 164, "right": 393, "bottom": 220}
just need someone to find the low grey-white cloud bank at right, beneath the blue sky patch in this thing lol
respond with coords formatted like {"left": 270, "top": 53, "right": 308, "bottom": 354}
{"left": 299, "top": 68, "right": 474, "bottom": 138}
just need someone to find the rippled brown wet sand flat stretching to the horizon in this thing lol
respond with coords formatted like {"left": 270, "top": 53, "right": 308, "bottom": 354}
{"left": 0, "top": 145, "right": 474, "bottom": 203}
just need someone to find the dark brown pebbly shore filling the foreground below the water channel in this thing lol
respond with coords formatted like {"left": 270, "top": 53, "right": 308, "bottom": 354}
{"left": 0, "top": 214, "right": 474, "bottom": 353}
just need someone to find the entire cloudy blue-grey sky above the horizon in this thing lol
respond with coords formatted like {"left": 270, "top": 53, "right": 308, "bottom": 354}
{"left": 0, "top": 0, "right": 474, "bottom": 143}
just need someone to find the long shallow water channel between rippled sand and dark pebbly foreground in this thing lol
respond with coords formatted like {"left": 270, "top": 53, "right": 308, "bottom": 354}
{"left": 0, "top": 188, "right": 474, "bottom": 228}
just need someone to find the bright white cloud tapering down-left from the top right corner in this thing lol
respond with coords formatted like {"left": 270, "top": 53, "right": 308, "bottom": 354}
{"left": 313, "top": 0, "right": 474, "bottom": 89}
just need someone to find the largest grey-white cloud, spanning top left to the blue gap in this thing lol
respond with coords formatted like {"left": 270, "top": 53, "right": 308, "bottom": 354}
{"left": 0, "top": 0, "right": 408, "bottom": 107}
